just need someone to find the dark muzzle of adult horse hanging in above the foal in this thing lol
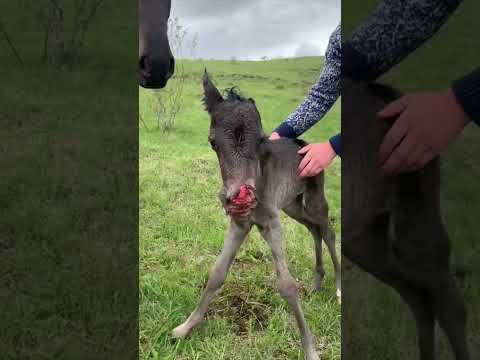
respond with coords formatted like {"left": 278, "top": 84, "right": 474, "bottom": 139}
{"left": 138, "top": 0, "right": 175, "bottom": 89}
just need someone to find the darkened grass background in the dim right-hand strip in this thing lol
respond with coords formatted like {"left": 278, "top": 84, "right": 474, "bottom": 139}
{"left": 342, "top": 0, "right": 480, "bottom": 360}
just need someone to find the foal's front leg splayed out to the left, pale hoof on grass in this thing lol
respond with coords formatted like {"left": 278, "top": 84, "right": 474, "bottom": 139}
{"left": 172, "top": 220, "right": 252, "bottom": 339}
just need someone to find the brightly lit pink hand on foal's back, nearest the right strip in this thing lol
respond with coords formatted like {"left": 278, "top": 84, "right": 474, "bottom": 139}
{"left": 298, "top": 142, "right": 337, "bottom": 177}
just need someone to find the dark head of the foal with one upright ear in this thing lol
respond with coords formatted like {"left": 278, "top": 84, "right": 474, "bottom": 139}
{"left": 203, "top": 72, "right": 265, "bottom": 215}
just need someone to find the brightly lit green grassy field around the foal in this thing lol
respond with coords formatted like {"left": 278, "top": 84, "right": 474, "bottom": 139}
{"left": 139, "top": 58, "right": 340, "bottom": 360}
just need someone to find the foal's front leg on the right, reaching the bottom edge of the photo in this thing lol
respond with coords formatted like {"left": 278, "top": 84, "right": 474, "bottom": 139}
{"left": 259, "top": 216, "right": 319, "bottom": 360}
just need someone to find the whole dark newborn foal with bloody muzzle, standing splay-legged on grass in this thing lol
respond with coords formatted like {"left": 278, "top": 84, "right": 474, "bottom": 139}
{"left": 172, "top": 72, "right": 341, "bottom": 360}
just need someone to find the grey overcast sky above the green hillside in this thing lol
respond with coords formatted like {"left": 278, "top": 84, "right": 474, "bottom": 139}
{"left": 171, "top": 0, "right": 340, "bottom": 60}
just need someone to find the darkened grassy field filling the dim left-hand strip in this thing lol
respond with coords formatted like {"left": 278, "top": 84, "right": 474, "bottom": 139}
{"left": 0, "top": 1, "right": 138, "bottom": 360}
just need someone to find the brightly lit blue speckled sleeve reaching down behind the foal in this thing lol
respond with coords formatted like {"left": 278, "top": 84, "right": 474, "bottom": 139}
{"left": 275, "top": 25, "right": 342, "bottom": 138}
